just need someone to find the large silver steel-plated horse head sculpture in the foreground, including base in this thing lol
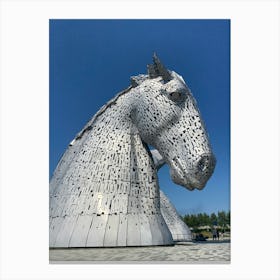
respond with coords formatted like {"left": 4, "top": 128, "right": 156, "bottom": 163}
{"left": 50, "top": 55, "right": 215, "bottom": 247}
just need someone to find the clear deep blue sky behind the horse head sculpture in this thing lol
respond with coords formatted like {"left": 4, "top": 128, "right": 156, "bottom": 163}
{"left": 50, "top": 20, "right": 230, "bottom": 214}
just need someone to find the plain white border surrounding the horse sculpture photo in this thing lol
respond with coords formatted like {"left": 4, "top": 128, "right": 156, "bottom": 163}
{"left": 0, "top": 0, "right": 280, "bottom": 280}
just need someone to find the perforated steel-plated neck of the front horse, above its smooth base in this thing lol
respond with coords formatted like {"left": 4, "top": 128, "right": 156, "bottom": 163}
{"left": 53, "top": 93, "right": 160, "bottom": 215}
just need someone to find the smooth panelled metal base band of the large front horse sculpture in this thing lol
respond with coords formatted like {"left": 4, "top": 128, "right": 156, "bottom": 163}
{"left": 49, "top": 213, "right": 174, "bottom": 248}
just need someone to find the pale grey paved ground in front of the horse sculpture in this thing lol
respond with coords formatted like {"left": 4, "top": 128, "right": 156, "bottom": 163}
{"left": 49, "top": 240, "right": 230, "bottom": 264}
